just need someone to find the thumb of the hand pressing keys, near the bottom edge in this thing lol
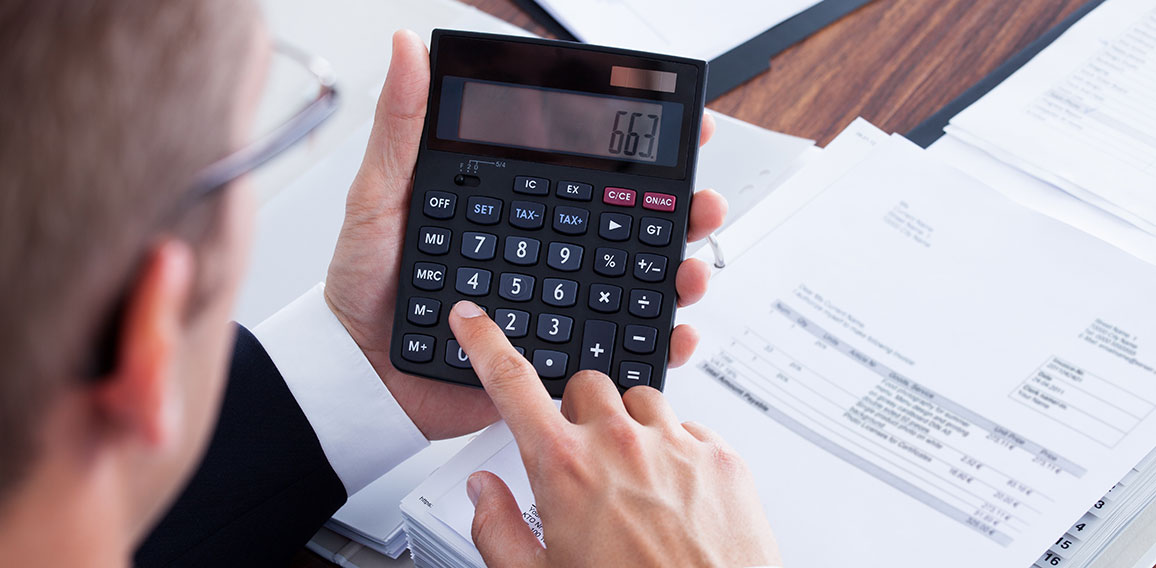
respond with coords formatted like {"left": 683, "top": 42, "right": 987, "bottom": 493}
{"left": 466, "top": 471, "right": 546, "bottom": 567}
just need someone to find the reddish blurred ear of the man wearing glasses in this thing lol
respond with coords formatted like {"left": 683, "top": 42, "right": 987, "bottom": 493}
{"left": 96, "top": 239, "right": 195, "bottom": 447}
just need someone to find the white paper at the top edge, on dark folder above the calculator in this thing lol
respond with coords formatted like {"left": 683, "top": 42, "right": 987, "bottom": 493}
{"left": 536, "top": 0, "right": 818, "bottom": 60}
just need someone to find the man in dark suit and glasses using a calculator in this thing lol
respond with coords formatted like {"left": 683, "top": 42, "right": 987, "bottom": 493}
{"left": 0, "top": 0, "right": 778, "bottom": 566}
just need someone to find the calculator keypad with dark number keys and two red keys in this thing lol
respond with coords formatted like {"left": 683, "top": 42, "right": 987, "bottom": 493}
{"left": 394, "top": 166, "right": 683, "bottom": 397}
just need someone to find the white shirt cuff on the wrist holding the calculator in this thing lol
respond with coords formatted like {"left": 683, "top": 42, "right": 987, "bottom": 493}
{"left": 253, "top": 283, "right": 429, "bottom": 495}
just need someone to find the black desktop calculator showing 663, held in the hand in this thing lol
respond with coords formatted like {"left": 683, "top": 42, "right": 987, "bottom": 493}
{"left": 391, "top": 30, "right": 706, "bottom": 397}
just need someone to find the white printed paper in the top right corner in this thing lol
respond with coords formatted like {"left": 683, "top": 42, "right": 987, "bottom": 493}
{"left": 948, "top": 0, "right": 1156, "bottom": 233}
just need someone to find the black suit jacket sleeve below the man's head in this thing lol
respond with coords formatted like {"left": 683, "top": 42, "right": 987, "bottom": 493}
{"left": 135, "top": 327, "right": 346, "bottom": 567}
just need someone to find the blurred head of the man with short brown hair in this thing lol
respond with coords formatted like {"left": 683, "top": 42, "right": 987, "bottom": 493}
{"left": 0, "top": 0, "right": 268, "bottom": 550}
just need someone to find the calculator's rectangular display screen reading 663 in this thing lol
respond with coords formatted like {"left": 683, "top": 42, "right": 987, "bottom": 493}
{"left": 438, "top": 78, "right": 682, "bottom": 165}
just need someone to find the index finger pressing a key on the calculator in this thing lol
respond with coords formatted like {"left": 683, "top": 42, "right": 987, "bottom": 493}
{"left": 450, "top": 300, "right": 565, "bottom": 448}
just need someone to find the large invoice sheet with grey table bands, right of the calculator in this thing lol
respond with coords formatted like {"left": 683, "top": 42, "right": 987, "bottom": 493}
{"left": 670, "top": 138, "right": 1156, "bottom": 567}
